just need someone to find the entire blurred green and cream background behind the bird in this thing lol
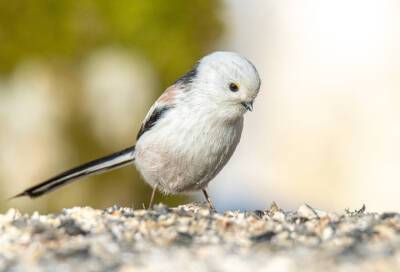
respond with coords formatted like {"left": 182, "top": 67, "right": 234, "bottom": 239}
{"left": 0, "top": 0, "right": 400, "bottom": 212}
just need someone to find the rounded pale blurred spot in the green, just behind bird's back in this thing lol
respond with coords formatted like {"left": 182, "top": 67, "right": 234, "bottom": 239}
{"left": 83, "top": 48, "right": 159, "bottom": 148}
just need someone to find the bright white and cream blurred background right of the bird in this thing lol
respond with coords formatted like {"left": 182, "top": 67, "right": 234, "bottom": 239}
{"left": 211, "top": 0, "right": 400, "bottom": 211}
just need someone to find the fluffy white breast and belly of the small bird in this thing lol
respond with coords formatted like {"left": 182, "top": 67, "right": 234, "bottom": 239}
{"left": 135, "top": 106, "right": 243, "bottom": 193}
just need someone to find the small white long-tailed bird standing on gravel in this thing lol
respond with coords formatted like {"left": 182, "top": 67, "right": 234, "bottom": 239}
{"left": 15, "top": 52, "right": 261, "bottom": 209}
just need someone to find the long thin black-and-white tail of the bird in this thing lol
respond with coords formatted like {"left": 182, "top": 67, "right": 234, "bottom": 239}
{"left": 13, "top": 146, "right": 135, "bottom": 198}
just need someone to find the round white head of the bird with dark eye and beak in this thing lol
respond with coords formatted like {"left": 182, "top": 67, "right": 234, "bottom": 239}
{"left": 188, "top": 51, "right": 261, "bottom": 116}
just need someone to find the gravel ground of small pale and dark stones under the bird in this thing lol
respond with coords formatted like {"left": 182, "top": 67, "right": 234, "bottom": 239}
{"left": 0, "top": 203, "right": 400, "bottom": 272}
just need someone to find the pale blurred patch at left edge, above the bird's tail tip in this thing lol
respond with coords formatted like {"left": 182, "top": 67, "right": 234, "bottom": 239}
{"left": 0, "top": 61, "right": 68, "bottom": 210}
